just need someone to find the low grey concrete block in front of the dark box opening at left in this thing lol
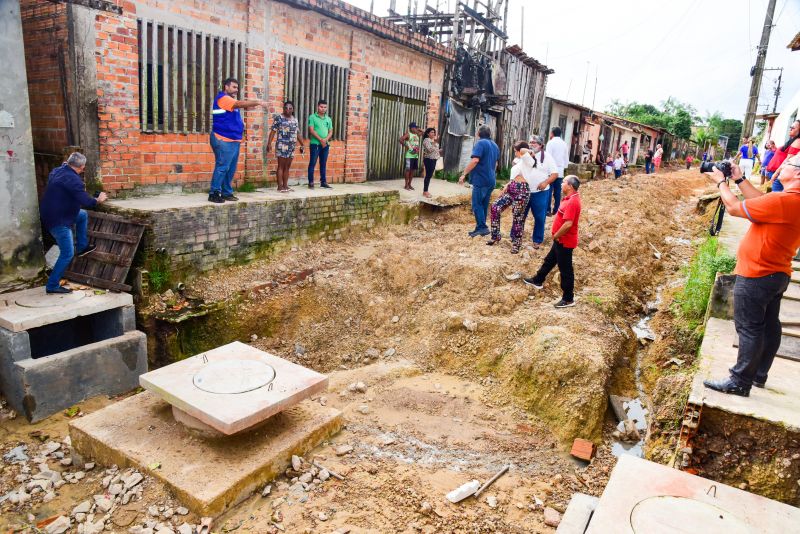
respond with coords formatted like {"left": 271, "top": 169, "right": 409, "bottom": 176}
{"left": 13, "top": 330, "right": 147, "bottom": 422}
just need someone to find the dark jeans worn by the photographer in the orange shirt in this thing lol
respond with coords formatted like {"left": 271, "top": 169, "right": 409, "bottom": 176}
{"left": 730, "top": 273, "right": 789, "bottom": 387}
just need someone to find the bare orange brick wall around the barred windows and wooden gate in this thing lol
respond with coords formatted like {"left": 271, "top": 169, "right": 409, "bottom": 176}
{"left": 23, "top": 0, "right": 449, "bottom": 195}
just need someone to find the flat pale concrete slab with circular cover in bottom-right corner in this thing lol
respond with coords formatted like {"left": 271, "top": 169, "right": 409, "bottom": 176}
{"left": 584, "top": 455, "right": 800, "bottom": 534}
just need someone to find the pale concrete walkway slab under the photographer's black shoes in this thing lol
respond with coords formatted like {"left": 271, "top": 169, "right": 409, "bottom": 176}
{"left": 689, "top": 318, "right": 800, "bottom": 432}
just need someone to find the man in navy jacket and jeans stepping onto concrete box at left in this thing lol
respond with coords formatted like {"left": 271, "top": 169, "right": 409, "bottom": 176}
{"left": 39, "top": 152, "right": 106, "bottom": 295}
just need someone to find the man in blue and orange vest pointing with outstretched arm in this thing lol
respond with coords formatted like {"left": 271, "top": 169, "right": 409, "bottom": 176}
{"left": 208, "top": 78, "right": 267, "bottom": 204}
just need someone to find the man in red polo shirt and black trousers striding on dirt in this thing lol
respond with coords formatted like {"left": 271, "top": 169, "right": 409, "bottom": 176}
{"left": 523, "top": 175, "right": 581, "bottom": 308}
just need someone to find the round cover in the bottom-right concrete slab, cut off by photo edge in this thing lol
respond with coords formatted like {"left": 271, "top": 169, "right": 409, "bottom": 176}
{"left": 631, "top": 495, "right": 757, "bottom": 534}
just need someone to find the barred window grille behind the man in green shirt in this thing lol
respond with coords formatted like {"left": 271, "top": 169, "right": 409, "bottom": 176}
{"left": 284, "top": 54, "right": 350, "bottom": 141}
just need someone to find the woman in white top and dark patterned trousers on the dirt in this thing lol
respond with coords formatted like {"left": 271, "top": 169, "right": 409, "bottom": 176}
{"left": 486, "top": 141, "right": 536, "bottom": 254}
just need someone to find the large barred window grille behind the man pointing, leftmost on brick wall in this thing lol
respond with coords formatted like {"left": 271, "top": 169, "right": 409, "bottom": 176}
{"left": 138, "top": 19, "right": 245, "bottom": 133}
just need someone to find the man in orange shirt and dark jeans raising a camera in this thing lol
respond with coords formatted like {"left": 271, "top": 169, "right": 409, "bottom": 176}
{"left": 703, "top": 156, "right": 800, "bottom": 397}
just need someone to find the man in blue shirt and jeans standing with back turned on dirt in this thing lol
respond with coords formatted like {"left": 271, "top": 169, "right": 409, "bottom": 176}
{"left": 458, "top": 125, "right": 500, "bottom": 237}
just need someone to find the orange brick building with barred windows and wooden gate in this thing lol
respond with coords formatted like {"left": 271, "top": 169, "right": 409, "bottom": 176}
{"left": 20, "top": 0, "right": 453, "bottom": 194}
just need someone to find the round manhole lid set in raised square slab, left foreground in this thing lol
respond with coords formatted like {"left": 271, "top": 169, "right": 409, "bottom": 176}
{"left": 193, "top": 360, "right": 275, "bottom": 395}
